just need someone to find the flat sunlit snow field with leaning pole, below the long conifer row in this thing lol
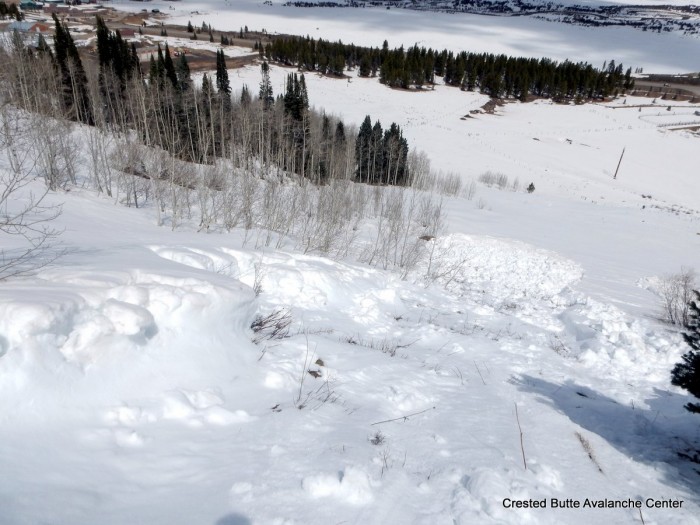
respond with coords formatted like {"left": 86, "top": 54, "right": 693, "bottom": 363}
{"left": 230, "top": 66, "right": 700, "bottom": 211}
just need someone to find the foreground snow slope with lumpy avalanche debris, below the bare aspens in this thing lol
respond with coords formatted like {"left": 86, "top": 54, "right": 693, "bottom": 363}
{"left": 0, "top": 179, "right": 700, "bottom": 524}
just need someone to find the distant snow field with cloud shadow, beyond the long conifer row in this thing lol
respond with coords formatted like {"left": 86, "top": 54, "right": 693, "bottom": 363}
{"left": 110, "top": 0, "right": 700, "bottom": 73}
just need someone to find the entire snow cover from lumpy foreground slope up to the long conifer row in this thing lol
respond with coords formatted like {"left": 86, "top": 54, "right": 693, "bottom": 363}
{"left": 0, "top": 2, "right": 700, "bottom": 525}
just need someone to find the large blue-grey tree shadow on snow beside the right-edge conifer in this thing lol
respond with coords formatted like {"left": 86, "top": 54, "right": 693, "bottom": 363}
{"left": 515, "top": 375, "right": 700, "bottom": 501}
